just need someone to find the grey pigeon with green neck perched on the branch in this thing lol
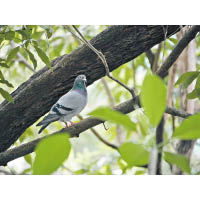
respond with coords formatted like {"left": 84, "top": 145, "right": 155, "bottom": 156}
{"left": 36, "top": 74, "right": 88, "bottom": 134}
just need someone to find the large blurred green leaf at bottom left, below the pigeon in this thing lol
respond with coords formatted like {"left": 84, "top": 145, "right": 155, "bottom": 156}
{"left": 33, "top": 134, "right": 71, "bottom": 175}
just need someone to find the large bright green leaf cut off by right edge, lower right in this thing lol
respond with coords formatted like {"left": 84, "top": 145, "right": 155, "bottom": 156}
{"left": 172, "top": 114, "right": 200, "bottom": 140}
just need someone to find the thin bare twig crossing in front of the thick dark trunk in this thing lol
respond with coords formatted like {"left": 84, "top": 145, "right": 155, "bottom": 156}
{"left": 70, "top": 25, "right": 136, "bottom": 98}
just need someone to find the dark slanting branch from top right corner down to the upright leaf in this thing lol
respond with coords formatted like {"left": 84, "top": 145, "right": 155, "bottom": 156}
{"left": 156, "top": 26, "right": 200, "bottom": 78}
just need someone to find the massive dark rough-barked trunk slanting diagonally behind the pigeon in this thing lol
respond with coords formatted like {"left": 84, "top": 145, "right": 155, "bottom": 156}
{"left": 0, "top": 26, "right": 179, "bottom": 152}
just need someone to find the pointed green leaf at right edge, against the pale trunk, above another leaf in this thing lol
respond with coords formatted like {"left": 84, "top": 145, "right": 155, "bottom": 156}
{"left": 175, "top": 71, "right": 200, "bottom": 89}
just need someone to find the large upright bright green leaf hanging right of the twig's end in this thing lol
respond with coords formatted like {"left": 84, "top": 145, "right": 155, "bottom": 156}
{"left": 140, "top": 74, "right": 167, "bottom": 126}
